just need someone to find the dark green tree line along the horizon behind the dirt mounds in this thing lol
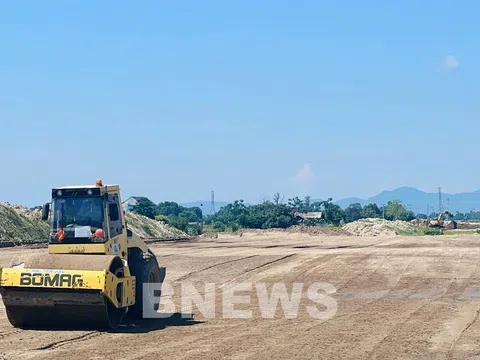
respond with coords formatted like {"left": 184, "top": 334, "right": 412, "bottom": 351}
{"left": 132, "top": 193, "right": 416, "bottom": 234}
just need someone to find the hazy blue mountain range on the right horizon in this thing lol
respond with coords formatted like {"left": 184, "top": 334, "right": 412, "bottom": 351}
{"left": 335, "top": 187, "right": 480, "bottom": 213}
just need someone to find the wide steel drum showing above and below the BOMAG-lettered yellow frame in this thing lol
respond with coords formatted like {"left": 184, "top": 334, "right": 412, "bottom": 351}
{"left": 0, "top": 254, "right": 126, "bottom": 330}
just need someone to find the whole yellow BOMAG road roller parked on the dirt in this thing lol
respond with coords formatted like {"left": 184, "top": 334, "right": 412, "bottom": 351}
{"left": 0, "top": 180, "right": 165, "bottom": 329}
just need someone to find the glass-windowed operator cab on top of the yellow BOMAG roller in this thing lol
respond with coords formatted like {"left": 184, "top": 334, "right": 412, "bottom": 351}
{"left": 42, "top": 180, "right": 123, "bottom": 244}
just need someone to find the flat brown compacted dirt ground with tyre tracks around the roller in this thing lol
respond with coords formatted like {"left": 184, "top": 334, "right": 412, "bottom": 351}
{"left": 0, "top": 233, "right": 480, "bottom": 360}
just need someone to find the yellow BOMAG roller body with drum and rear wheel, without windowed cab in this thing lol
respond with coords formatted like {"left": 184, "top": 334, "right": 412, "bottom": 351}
{"left": 0, "top": 183, "right": 165, "bottom": 329}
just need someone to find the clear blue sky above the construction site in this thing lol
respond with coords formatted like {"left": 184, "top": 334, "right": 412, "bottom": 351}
{"left": 0, "top": 0, "right": 480, "bottom": 205}
